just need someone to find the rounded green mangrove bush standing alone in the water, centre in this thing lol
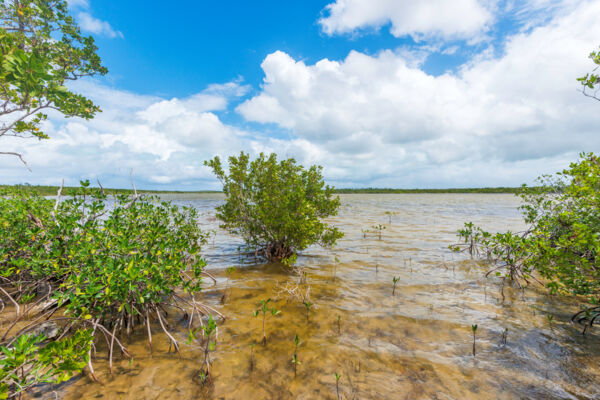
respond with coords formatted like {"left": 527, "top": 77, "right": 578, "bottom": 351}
{"left": 205, "top": 152, "right": 343, "bottom": 261}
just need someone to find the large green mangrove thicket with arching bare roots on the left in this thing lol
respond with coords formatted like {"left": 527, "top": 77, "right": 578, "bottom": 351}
{"left": 0, "top": 181, "right": 210, "bottom": 380}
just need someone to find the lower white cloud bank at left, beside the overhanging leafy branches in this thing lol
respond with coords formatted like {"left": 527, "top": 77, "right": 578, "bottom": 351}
{"left": 0, "top": 80, "right": 252, "bottom": 189}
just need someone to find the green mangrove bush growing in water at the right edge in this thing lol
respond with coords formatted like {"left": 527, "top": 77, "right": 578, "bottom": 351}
{"left": 454, "top": 153, "right": 600, "bottom": 322}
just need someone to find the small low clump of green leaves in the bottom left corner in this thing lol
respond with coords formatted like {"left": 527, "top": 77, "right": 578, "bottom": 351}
{"left": 0, "top": 330, "right": 93, "bottom": 399}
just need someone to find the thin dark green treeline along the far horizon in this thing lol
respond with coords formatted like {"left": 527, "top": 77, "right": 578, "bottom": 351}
{"left": 0, "top": 185, "right": 521, "bottom": 196}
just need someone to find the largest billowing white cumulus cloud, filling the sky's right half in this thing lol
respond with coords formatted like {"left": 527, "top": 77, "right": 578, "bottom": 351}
{"left": 237, "top": 1, "right": 600, "bottom": 186}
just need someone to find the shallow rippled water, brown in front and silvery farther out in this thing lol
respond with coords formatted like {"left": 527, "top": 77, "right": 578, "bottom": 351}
{"left": 37, "top": 194, "right": 600, "bottom": 399}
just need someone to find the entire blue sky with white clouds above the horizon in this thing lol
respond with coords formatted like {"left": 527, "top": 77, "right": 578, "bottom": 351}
{"left": 0, "top": 0, "right": 600, "bottom": 190}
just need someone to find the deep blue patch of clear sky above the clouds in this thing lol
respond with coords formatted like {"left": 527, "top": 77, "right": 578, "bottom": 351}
{"left": 90, "top": 0, "right": 422, "bottom": 97}
